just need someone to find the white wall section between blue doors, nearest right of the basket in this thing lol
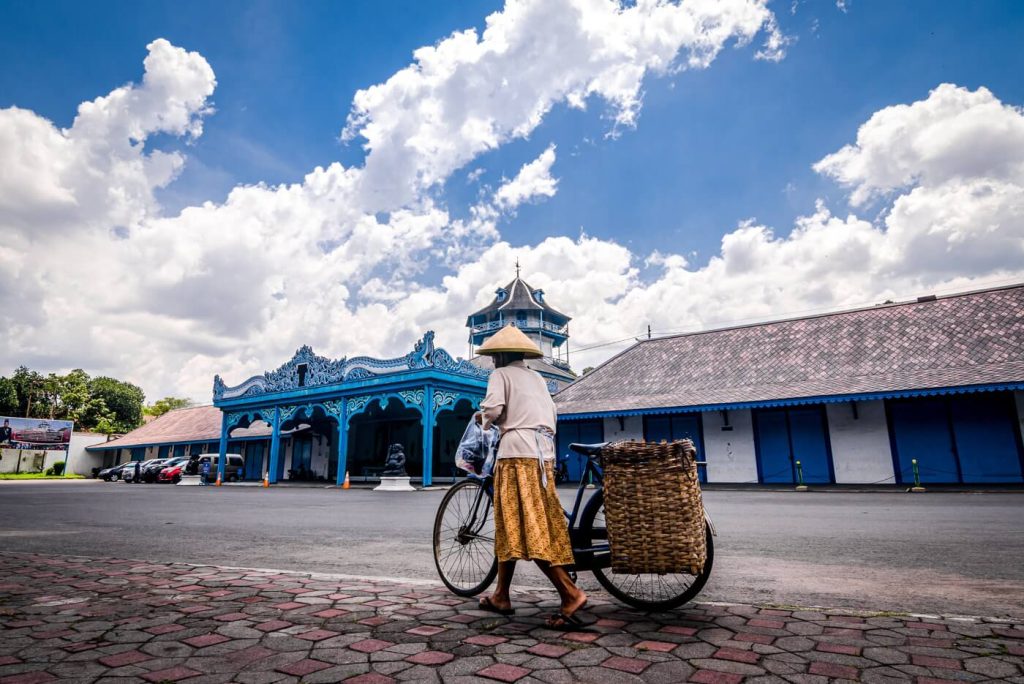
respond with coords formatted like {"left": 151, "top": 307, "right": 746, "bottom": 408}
{"left": 698, "top": 409, "right": 758, "bottom": 482}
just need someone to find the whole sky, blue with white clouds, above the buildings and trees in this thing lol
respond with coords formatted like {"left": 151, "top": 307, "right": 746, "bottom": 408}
{"left": 0, "top": 0, "right": 1024, "bottom": 402}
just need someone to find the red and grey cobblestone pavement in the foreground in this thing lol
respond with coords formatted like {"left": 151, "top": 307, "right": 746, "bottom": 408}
{"left": 0, "top": 553, "right": 1024, "bottom": 684}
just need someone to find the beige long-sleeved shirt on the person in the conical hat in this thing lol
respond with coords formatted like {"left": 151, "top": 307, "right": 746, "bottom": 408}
{"left": 480, "top": 361, "right": 557, "bottom": 459}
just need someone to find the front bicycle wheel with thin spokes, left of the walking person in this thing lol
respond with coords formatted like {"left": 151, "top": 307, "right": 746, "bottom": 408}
{"left": 434, "top": 479, "right": 498, "bottom": 596}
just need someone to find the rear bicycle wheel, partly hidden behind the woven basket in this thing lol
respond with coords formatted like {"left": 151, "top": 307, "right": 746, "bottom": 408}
{"left": 580, "top": 489, "right": 715, "bottom": 610}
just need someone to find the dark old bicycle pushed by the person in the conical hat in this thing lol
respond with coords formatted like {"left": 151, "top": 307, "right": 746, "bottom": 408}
{"left": 433, "top": 442, "right": 716, "bottom": 610}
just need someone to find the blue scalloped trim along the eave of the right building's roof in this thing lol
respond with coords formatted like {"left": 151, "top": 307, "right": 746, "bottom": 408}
{"left": 558, "top": 382, "right": 1024, "bottom": 421}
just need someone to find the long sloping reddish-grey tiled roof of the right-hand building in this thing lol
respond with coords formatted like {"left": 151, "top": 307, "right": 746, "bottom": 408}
{"left": 555, "top": 286, "right": 1024, "bottom": 415}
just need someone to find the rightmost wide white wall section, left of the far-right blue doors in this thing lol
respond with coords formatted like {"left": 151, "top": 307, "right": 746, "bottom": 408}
{"left": 825, "top": 399, "right": 896, "bottom": 484}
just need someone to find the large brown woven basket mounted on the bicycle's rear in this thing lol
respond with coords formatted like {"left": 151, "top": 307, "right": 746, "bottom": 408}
{"left": 601, "top": 439, "right": 708, "bottom": 574}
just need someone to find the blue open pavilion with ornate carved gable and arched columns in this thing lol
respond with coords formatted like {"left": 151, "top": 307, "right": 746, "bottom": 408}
{"left": 213, "top": 332, "right": 489, "bottom": 485}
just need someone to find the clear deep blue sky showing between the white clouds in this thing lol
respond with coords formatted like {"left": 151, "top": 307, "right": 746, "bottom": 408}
{"left": 0, "top": 0, "right": 1024, "bottom": 260}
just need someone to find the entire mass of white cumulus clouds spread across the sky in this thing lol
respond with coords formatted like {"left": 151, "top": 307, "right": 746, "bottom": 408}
{"left": 6, "top": 9, "right": 1024, "bottom": 400}
